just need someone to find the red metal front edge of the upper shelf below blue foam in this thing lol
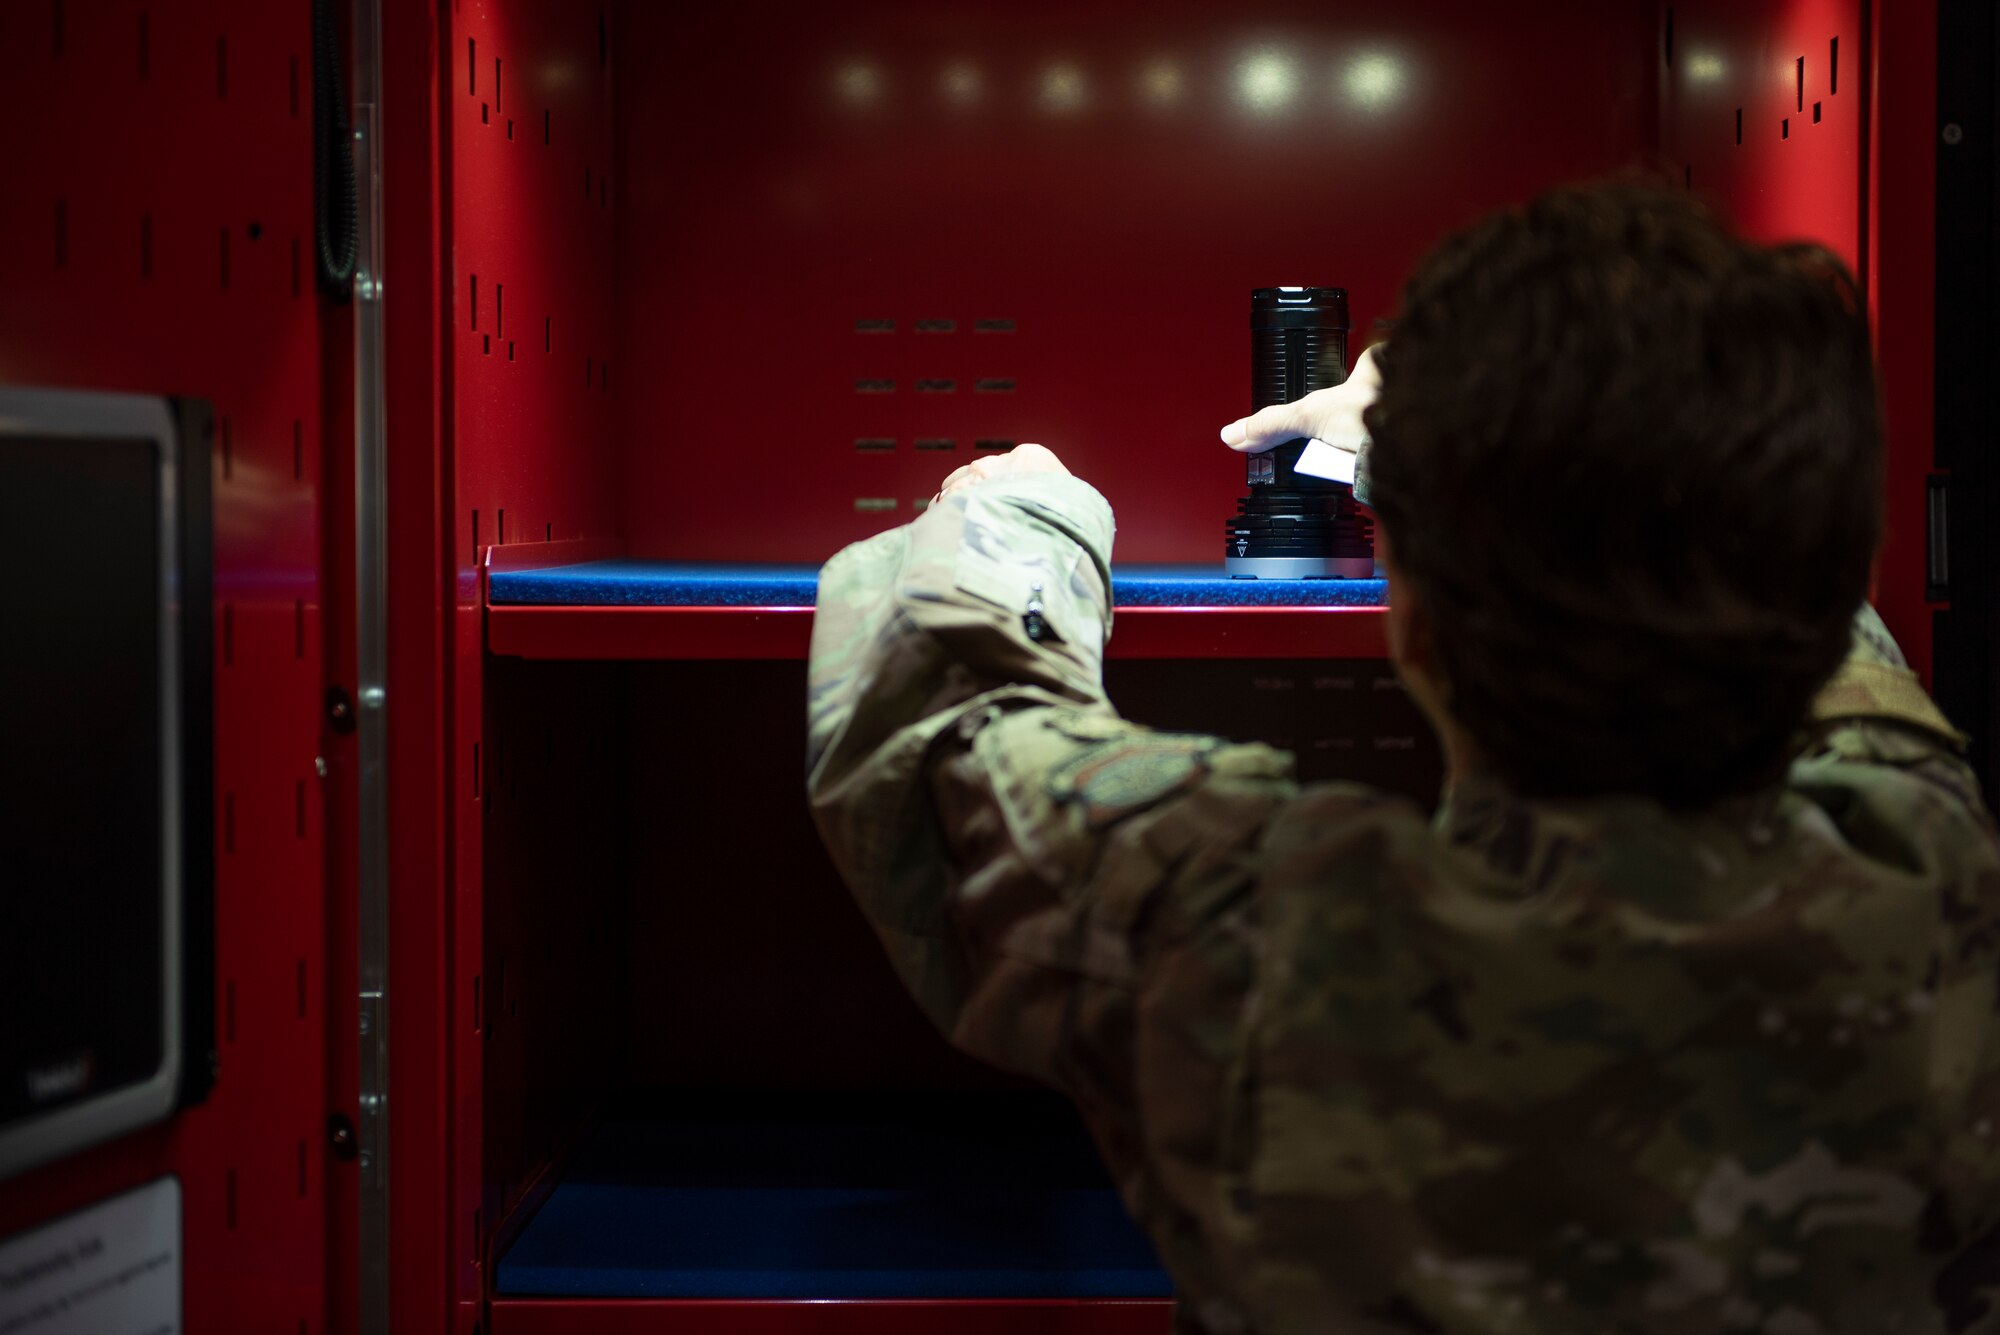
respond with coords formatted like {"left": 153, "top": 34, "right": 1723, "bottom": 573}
{"left": 486, "top": 606, "right": 1388, "bottom": 660}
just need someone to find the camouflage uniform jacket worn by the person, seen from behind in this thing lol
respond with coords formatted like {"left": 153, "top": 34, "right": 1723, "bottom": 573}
{"left": 808, "top": 476, "right": 2000, "bottom": 1335}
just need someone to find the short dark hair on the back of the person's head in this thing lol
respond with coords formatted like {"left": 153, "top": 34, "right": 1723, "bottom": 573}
{"left": 1366, "top": 182, "right": 1882, "bottom": 809}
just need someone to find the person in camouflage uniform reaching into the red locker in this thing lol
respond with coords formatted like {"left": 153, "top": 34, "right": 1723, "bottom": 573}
{"left": 808, "top": 186, "right": 2000, "bottom": 1335}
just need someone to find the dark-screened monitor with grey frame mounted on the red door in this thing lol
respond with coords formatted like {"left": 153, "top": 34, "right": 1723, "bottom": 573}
{"left": 0, "top": 386, "right": 214, "bottom": 1179}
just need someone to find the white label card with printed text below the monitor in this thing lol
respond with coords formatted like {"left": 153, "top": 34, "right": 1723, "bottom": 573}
{"left": 0, "top": 1177, "right": 180, "bottom": 1335}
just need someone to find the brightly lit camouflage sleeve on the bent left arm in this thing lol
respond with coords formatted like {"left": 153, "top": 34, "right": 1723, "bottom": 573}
{"left": 808, "top": 478, "right": 1292, "bottom": 1107}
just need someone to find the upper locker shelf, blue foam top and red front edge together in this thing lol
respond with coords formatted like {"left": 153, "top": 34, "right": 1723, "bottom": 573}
{"left": 486, "top": 548, "right": 1386, "bottom": 660}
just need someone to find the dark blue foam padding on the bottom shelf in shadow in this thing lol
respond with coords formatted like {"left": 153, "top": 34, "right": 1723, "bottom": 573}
{"left": 496, "top": 1117, "right": 1172, "bottom": 1299}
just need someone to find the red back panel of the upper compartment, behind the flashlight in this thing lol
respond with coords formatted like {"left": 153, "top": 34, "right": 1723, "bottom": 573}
{"left": 618, "top": 0, "right": 1656, "bottom": 562}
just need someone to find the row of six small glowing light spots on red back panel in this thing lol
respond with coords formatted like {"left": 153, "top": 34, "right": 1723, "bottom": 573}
{"left": 834, "top": 48, "right": 1410, "bottom": 116}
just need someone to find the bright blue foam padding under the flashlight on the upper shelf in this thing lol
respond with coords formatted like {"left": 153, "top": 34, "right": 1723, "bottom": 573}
{"left": 488, "top": 560, "right": 1384, "bottom": 608}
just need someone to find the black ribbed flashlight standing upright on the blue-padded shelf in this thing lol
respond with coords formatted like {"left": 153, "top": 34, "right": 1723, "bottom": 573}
{"left": 1222, "top": 288, "right": 1374, "bottom": 580}
